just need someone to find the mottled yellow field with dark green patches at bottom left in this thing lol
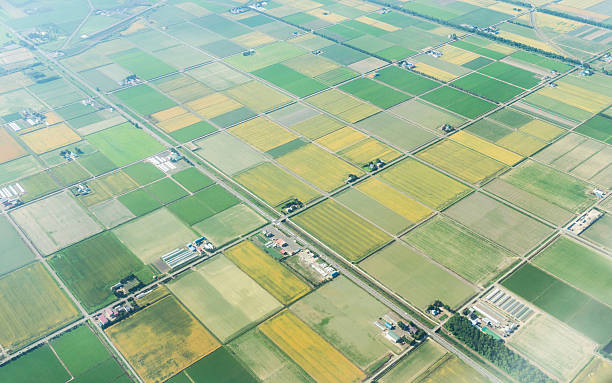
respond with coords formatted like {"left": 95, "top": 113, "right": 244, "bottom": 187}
{"left": 106, "top": 296, "right": 220, "bottom": 383}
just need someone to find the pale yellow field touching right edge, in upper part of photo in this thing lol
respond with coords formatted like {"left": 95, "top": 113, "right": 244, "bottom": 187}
{"left": 538, "top": 81, "right": 612, "bottom": 114}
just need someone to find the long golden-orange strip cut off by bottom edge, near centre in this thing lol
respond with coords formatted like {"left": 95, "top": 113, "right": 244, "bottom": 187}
{"left": 259, "top": 311, "right": 365, "bottom": 383}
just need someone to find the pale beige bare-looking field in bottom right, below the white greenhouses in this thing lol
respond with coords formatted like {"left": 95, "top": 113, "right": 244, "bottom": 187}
{"left": 510, "top": 315, "right": 595, "bottom": 381}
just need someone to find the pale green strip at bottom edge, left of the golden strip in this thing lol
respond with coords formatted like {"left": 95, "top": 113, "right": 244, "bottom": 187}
{"left": 228, "top": 329, "right": 314, "bottom": 383}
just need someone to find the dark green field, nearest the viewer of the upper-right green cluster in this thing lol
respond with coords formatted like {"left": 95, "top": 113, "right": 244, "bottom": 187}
{"left": 422, "top": 86, "right": 495, "bottom": 118}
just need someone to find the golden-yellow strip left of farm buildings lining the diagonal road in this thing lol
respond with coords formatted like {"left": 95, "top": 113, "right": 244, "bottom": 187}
{"left": 225, "top": 240, "right": 310, "bottom": 305}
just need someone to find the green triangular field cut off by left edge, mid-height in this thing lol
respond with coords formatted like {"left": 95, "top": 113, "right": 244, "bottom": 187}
{"left": 0, "top": 215, "right": 34, "bottom": 275}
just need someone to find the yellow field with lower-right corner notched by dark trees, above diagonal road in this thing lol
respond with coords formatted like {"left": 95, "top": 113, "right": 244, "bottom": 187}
{"left": 234, "top": 162, "right": 320, "bottom": 207}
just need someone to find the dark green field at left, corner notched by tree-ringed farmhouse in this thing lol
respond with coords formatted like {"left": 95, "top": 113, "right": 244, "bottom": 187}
{"left": 49, "top": 231, "right": 153, "bottom": 311}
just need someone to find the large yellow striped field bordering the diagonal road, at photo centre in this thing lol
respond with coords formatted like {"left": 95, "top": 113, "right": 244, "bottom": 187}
{"left": 293, "top": 199, "right": 392, "bottom": 262}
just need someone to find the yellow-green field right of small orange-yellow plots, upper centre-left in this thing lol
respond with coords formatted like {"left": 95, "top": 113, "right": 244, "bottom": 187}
{"left": 227, "top": 81, "right": 291, "bottom": 113}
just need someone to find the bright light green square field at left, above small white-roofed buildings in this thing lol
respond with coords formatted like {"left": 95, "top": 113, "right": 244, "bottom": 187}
{"left": 87, "top": 122, "right": 164, "bottom": 166}
